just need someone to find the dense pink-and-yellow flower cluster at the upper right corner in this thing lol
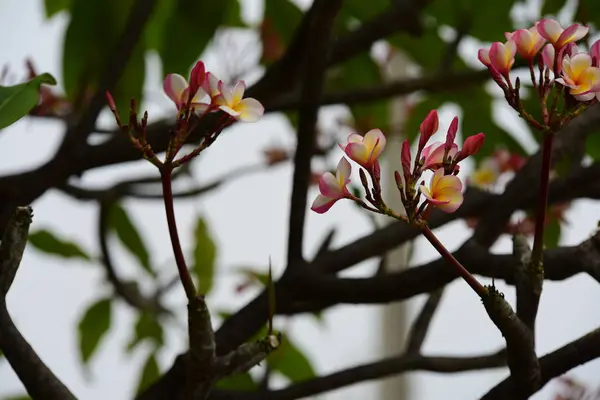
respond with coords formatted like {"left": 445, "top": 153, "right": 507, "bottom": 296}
{"left": 478, "top": 19, "right": 600, "bottom": 130}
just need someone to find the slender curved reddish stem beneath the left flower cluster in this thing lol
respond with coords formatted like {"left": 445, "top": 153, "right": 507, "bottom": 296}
{"left": 160, "top": 164, "right": 196, "bottom": 300}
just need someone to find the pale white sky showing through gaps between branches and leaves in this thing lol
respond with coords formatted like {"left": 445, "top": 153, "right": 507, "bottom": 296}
{"left": 0, "top": 0, "right": 600, "bottom": 400}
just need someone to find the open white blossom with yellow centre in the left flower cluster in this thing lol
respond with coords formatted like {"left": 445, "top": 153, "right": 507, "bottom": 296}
{"left": 214, "top": 78, "right": 265, "bottom": 122}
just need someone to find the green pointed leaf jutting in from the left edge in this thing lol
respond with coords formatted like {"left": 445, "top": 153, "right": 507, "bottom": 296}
{"left": 0, "top": 73, "right": 56, "bottom": 129}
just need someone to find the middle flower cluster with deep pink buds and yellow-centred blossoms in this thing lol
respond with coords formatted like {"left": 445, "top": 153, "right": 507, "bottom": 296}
{"left": 311, "top": 110, "right": 485, "bottom": 223}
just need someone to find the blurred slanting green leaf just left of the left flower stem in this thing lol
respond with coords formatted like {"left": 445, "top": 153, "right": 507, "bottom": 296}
{"left": 110, "top": 203, "right": 154, "bottom": 276}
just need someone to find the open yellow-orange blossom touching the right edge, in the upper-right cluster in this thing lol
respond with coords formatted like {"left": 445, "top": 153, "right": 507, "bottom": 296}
{"left": 556, "top": 53, "right": 600, "bottom": 101}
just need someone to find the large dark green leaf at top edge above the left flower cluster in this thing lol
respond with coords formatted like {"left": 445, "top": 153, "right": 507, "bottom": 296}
{"left": 158, "top": 0, "right": 234, "bottom": 76}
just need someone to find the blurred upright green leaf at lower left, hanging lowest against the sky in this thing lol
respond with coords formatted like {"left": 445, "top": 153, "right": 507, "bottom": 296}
{"left": 78, "top": 299, "right": 112, "bottom": 364}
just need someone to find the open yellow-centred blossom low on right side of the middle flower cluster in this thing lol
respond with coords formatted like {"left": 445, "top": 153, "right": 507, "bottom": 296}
{"left": 419, "top": 168, "right": 463, "bottom": 213}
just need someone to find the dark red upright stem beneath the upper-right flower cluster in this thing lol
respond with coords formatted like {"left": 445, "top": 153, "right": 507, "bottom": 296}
{"left": 531, "top": 133, "right": 554, "bottom": 265}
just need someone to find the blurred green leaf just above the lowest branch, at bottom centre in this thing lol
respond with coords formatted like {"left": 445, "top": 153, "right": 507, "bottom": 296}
{"left": 267, "top": 335, "right": 315, "bottom": 382}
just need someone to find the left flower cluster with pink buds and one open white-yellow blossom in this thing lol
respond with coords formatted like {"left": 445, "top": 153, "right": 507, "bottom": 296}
{"left": 163, "top": 61, "right": 264, "bottom": 122}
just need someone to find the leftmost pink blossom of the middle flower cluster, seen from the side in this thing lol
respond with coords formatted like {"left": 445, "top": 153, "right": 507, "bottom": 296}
{"left": 310, "top": 157, "right": 352, "bottom": 214}
